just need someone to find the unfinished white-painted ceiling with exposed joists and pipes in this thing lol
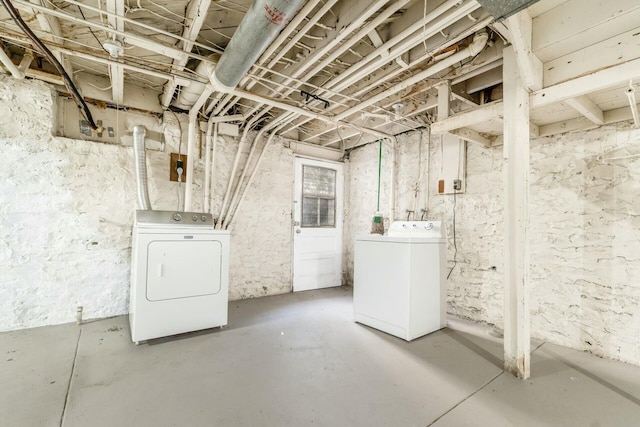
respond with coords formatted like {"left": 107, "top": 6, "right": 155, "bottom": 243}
{"left": 0, "top": 0, "right": 640, "bottom": 148}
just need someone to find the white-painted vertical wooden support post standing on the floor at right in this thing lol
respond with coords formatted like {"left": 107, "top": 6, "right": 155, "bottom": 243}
{"left": 503, "top": 47, "right": 531, "bottom": 379}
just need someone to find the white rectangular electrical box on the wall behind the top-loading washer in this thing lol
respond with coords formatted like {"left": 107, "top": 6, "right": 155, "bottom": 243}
{"left": 436, "top": 133, "right": 467, "bottom": 194}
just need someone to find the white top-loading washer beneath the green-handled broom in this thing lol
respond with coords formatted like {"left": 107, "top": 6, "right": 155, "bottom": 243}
{"left": 353, "top": 221, "right": 447, "bottom": 341}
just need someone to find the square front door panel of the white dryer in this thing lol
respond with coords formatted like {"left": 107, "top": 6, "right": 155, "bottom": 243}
{"left": 146, "top": 240, "right": 222, "bottom": 301}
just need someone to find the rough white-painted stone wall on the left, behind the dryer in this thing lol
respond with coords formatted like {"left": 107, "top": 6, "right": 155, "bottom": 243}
{"left": 0, "top": 75, "right": 294, "bottom": 330}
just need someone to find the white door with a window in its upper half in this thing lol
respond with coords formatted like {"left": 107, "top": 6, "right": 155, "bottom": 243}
{"left": 293, "top": 157, "right": 343, "bottom": 292}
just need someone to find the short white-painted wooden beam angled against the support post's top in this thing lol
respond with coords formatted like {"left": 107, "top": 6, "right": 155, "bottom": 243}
{"left": 507, "top": 10, "right": 542, "bottom": 91}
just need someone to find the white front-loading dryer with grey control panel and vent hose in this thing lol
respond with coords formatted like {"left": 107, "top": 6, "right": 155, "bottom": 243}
{"left": 129, "top": 211, "right": 230, "bottom": 344}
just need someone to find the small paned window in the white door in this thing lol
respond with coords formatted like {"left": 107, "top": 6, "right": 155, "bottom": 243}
{"left": 301, "top": 165, "right": 336, "bottom": 227}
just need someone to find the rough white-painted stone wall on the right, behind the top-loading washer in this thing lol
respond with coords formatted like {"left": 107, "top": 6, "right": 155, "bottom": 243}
{"left": 345, "top": 123, "right": 640, "bottom": 364}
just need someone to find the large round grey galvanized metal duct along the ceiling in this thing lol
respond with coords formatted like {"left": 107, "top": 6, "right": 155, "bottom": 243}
{"left": 211, "top": 0, "right": 304, "bottom": 92}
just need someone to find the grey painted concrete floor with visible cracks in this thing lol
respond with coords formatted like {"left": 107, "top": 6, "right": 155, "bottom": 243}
{"left": 0, "top": 288, "right": 640, "bottom": 427}
